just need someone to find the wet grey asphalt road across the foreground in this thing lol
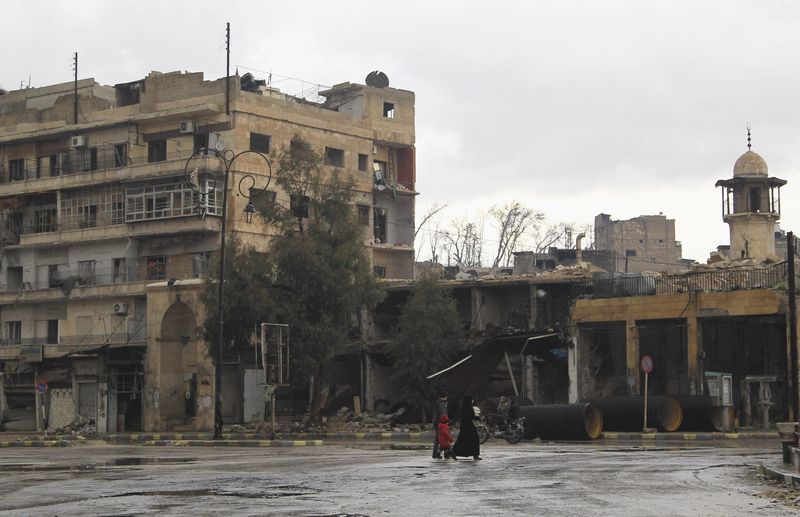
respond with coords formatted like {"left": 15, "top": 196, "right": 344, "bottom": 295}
{"left": 0, "top": 441, "right": 800, "bottom": 517}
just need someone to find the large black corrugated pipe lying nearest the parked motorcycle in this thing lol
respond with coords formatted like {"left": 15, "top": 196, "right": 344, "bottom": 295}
{"left": 519, "top": 403, "right": 603, "bottom": 440}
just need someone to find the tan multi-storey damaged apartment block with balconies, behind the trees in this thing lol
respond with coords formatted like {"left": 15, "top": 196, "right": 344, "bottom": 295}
{"left": 0, "top": 68, "right": 416, "bottom": 432}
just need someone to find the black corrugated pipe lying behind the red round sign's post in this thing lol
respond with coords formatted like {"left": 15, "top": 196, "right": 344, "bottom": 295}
{"left": 587, "top": 396, "right": 683, "bottom": 433}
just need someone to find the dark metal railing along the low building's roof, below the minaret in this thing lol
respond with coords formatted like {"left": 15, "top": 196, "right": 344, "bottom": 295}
{"left": 592, "top": 262, "right": 787, "bottom": 298}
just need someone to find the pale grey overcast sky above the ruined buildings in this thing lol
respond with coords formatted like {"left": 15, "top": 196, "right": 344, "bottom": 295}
{"left": 0, "top": 0, "right": 800, "bottom": 261}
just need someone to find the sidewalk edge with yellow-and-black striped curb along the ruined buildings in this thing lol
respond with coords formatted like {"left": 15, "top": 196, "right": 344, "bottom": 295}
{"left": 0, "top": 431, "right": 779, "bottom": 448}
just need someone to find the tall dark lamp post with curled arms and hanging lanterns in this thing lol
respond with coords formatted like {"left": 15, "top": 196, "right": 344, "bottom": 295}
{"left": 183, "top": 148, "right": 272, "bottom": 440}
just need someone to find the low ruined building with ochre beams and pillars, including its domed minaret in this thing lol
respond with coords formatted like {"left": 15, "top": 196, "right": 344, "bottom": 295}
{"left": 569, "top": 141, "right": 796, "bottom": 428}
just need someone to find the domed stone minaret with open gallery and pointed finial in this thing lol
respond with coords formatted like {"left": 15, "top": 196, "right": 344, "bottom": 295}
{"left": 716, "top": 126, "right": 786, "bottom": 260}
